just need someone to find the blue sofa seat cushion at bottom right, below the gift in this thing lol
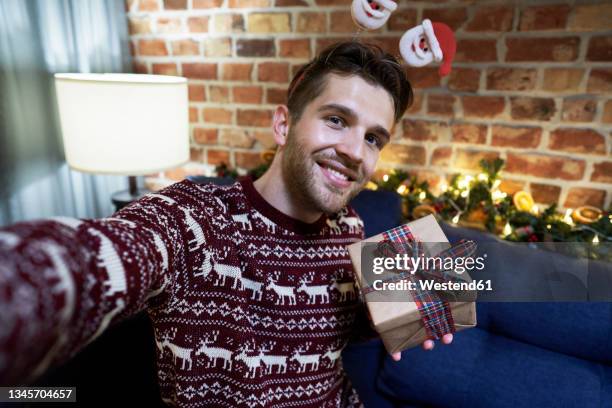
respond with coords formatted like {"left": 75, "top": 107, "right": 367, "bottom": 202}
{"left": 377, "top": 329, "right": 612, "bottom": 408}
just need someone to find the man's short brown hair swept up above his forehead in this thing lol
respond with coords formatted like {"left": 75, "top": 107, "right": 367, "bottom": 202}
{"left": 287, "top": 41, "right": 413, "bottom": 123}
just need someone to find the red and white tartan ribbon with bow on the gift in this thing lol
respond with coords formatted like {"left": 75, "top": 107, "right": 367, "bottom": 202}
{"left": 363, "top": 225, "right": 476, "bottom": 340}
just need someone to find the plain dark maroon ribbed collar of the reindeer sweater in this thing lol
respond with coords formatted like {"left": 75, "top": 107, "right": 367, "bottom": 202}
{"left": 238, "top": 175, "right": 327, "bottom": 234}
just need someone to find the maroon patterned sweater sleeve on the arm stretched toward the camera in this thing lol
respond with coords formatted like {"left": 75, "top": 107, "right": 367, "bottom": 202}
{"left": 0, "top": 187, "right": 186, "bottom": 385}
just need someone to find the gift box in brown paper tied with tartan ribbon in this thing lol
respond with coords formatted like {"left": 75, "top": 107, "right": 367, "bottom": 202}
{"left": 348, "top": 215, "right": 476, "bottom": 353}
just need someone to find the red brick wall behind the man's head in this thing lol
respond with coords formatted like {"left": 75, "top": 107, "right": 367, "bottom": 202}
{"left": 126, "top": 0, "right": 612, "bottom": 207}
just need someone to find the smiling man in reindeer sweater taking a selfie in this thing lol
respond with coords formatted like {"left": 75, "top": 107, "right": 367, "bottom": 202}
{"left": 0, "top": 42, "right": 452, "bottom": 407}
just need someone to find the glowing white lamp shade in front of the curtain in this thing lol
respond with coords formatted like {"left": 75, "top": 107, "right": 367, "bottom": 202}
{"left": 55, "top": 74, "right": 189, "bottom": 176}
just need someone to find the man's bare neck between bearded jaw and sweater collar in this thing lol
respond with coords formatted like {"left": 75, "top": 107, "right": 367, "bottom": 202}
{"left": 253, "top": 159, "right": 323, "bottom": 224}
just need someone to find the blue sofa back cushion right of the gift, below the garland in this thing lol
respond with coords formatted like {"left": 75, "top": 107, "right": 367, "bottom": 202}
{"left": 442, "top": 223, "right": 612, "bottom": 364}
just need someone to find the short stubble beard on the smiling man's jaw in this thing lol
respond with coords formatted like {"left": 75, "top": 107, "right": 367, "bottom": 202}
{"left": 281, "top": 131, "right": 365, "bottom": 215}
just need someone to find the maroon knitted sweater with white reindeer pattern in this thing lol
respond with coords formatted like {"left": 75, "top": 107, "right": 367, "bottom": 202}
{"left": 0, "top": 178, "right": 372, "bottom": 408}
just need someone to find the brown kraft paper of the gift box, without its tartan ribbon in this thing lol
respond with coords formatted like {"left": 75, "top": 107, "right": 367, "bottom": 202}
{"left": 348, "top": 215, "right": 476, "bottom": 353}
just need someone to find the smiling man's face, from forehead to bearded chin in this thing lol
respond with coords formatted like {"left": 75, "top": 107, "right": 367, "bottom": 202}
{"left": 282, "top": 74, "right": 394, "bottom": 214}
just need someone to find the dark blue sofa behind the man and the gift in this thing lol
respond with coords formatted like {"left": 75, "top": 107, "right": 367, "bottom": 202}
{"left": 342, "top": 192, "right": 612, "bottom": 408}
